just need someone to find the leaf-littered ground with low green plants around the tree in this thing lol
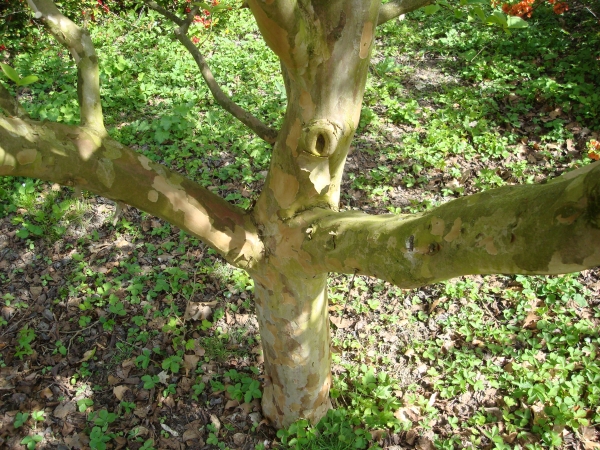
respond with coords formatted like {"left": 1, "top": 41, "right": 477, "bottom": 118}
{"left": 0, "top": 0, "right": 599, "bottom": 448}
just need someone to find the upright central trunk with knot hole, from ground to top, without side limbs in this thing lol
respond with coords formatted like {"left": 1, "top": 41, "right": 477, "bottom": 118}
{"left": 248, "top": 0, "right": 379, "bottom": 427}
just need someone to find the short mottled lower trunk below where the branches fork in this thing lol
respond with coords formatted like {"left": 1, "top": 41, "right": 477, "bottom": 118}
{"left": 254, "top": 265, "right": 331, "bottom": 428}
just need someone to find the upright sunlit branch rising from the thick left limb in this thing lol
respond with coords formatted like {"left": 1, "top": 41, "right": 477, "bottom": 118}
{"left": 27, "top": 0, "right": 105, "bottom": 132}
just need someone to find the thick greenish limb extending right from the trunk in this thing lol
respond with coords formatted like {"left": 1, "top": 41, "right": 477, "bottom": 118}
{"left": 302, "top": 162, "right": 600, "bottom": 288}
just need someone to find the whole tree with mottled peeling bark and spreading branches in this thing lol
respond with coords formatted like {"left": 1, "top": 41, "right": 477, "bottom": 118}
{"left": 0, "top": 0, "right": 600, "bottom": 427}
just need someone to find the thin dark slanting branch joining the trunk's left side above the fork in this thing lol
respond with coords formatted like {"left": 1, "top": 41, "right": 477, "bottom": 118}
{"left": 146, "top": 1, "right": 277, "bottom": 144}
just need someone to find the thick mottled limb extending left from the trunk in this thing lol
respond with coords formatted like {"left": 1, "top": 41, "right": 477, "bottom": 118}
{"left": 0, "top": 116, "right": 262, "bottom": 268}
